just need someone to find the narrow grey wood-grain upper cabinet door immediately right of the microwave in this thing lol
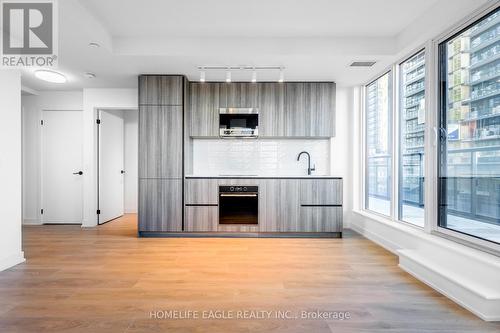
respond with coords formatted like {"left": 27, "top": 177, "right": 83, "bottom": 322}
{"left": 258, "top": 82, "right": 285, "bottom": 137}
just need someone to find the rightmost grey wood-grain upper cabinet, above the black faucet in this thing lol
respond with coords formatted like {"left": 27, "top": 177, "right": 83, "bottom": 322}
{"left": 284, "top": 82, "right": 335, "bottom": 137}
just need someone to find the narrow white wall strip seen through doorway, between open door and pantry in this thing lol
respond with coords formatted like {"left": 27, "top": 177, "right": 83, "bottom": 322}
{"left": 123, "top": 110, "right": 139, "bottom": 213}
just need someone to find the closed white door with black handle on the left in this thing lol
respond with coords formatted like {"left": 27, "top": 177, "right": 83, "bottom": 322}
{"left": 41, "top": 111, "right": 84, "bottom": 224}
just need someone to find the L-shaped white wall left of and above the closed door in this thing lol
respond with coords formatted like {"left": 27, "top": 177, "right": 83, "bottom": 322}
{"left": 21, "top": 91, "right": 83, "bottom": 224}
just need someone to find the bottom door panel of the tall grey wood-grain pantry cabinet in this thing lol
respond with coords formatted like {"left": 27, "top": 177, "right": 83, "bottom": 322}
{"left": 139, "top": 179, "right": 182, "bottom": 232}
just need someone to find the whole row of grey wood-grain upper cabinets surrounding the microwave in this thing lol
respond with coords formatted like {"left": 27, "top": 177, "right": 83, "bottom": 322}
{"left": 187, "top": 82, "right": 335, "bottom": 138}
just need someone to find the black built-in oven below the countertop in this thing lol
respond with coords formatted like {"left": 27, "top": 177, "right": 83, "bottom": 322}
{"left": 219, "top": 185, "right": 259, "bottom": 224}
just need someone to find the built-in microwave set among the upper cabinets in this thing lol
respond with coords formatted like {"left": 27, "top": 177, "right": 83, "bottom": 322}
{"left": 219, "top": 108, "right": 259, "bottom": 138}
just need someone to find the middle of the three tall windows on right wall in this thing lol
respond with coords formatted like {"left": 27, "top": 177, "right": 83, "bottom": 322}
{"left": 398, "top": 51, "right": 425, "bottom": 227}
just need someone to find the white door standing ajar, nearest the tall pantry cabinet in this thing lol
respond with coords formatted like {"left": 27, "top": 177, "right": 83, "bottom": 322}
{"left": 99, "top": 111, "right": 125, "bottom": 223}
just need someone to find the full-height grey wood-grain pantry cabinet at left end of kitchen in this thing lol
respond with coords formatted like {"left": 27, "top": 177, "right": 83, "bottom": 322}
{"left": 138, "top": 75, "right": 186, "bottom": 235}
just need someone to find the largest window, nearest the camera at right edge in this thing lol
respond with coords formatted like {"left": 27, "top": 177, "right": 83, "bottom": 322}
{"left": 438, "top": 9, "right": 500, "bottom": 243}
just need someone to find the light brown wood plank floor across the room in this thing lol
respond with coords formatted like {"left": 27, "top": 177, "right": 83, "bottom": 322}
{"left": 0, "top": 215, "right": 500, "bottom": 333}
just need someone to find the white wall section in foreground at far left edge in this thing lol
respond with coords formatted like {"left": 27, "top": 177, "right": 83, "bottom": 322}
{"left": 0, "top": 70, "right": 24, "bottom": 271}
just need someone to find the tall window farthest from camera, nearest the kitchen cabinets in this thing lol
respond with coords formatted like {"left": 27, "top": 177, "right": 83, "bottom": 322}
{"left": 365, "top": 72, "right": 392, "bottom": 216}
